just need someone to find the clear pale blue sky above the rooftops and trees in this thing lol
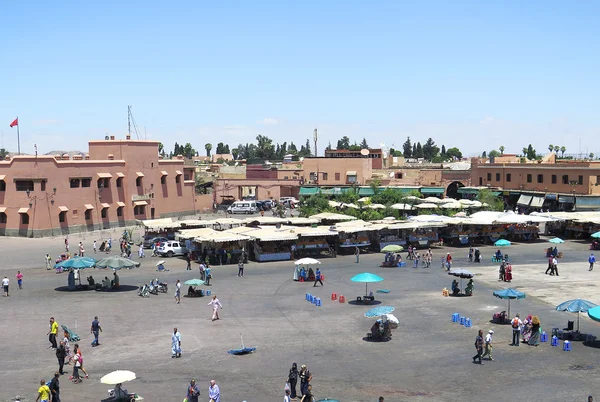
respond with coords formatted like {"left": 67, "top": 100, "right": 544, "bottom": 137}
{"left": 0, "top": 0, "right": 600, "bottom": 155}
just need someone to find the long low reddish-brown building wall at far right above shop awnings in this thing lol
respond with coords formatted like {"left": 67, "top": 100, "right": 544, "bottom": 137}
{"left": 471, "top": 161, "right": 600, "bottom": 195}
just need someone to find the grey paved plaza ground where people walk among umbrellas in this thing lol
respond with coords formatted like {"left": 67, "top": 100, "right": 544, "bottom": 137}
{"left": 0, "top": 229, "right": 600, "bottom": 402}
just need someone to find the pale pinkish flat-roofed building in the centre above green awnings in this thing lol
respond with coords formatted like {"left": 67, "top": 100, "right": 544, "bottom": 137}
{"left": 302, "top": 158, "right": 373, "bottom": 186}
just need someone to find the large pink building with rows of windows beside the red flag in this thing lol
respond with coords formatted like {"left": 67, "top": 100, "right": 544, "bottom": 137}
{"left": 0, "top": 137, "right": 198, "bottom": 237}
